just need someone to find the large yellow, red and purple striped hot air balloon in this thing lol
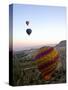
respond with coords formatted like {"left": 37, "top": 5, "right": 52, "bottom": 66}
{"left": 33, "top": 47, "right": 59, "bottom": 80}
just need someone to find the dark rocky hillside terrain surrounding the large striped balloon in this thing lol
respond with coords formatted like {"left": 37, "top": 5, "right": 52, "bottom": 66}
{"left": 13, "top": 41, "right": 66, "bottom": 86}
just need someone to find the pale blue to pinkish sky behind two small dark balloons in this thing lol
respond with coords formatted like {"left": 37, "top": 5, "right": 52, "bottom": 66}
{"left": 9, "top": 4, "right": 66, "bottom": 50}
